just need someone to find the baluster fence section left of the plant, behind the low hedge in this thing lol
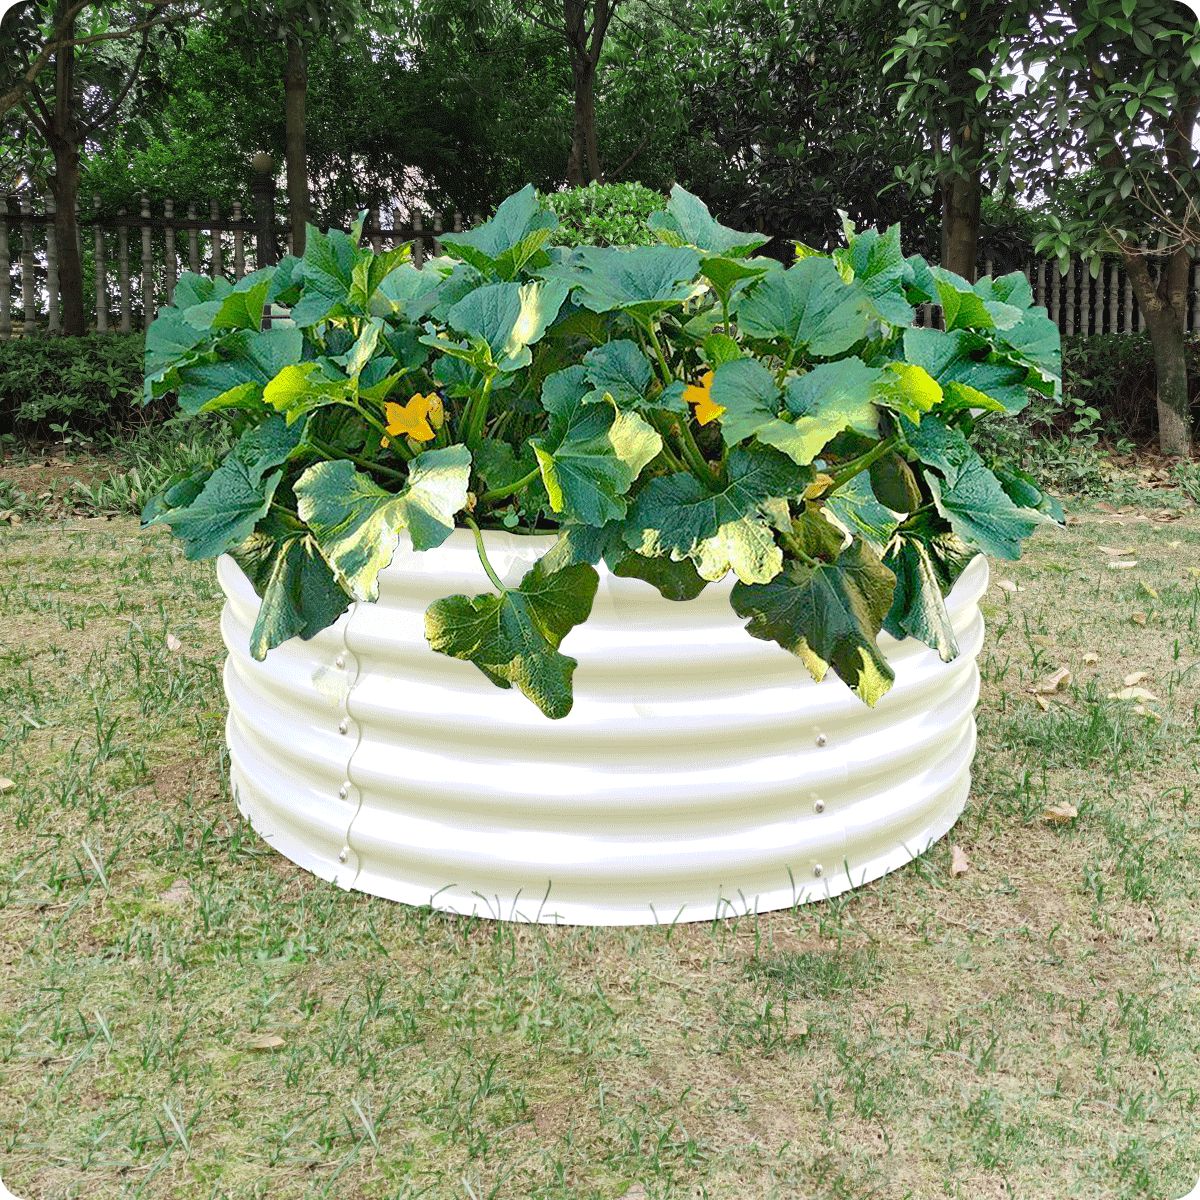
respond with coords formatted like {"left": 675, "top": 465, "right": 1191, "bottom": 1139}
{"left": 0, "top": 193, "right": 479, "bottom": 341}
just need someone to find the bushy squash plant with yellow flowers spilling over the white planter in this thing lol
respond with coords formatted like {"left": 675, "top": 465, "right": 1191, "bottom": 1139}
{"left": 142, "top": 187, "right": 1062, "bottom": 719}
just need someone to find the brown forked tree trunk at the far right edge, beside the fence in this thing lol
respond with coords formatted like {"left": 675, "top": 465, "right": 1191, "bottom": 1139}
{"left": 1121, "top": 247, "right": 1192, "bottom": 455}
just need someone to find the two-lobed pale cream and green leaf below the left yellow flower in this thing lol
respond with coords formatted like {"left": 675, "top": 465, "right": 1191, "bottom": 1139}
{"left": 294, "top": 445, "right": 470, "bottom": 600}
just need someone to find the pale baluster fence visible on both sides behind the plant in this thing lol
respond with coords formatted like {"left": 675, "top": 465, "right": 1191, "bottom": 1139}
{"left": 0, "top": 192, "right": 1200, "bottom": 341}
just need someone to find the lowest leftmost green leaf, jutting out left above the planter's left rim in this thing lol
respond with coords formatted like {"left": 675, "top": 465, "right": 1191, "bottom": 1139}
{"left": 144, "top": 416, "right": 308, "bottom": 559}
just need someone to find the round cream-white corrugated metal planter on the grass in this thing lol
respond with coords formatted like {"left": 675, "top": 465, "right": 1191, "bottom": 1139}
{"left": 217, "top": 529, "right": 988, "bottom": 925}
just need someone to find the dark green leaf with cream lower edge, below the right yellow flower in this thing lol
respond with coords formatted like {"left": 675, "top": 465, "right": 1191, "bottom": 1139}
{"left": 624, "top": 445, "right": 812, "bottom": 583}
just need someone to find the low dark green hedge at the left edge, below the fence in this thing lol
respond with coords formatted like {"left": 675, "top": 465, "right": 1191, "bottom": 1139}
{"left": 0, "top": 332, "right": 173, "bottom": 440}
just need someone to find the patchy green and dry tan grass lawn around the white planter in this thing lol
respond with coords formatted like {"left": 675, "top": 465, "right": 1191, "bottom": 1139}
{"left": 0, "top": 439, "right": 1200, "bottom": 1200}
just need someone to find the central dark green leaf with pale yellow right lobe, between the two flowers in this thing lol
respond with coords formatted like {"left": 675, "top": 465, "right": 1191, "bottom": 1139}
{"left": 530, "top": 366, "right": 662, "bottom": 526}
